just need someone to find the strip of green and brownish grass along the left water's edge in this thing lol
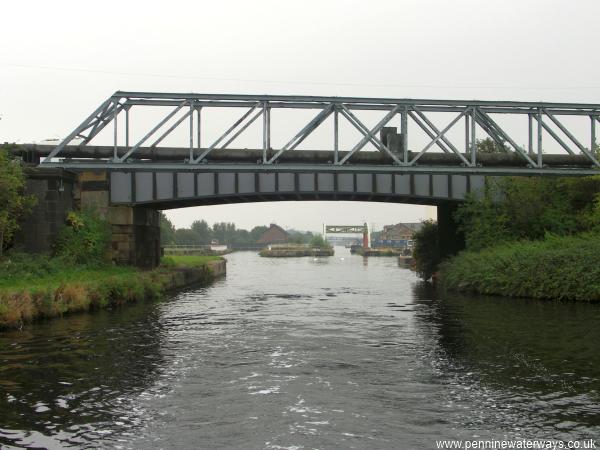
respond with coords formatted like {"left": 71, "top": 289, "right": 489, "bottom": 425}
{"left": 0, "top": 255, "right": 222, "bottom": 329}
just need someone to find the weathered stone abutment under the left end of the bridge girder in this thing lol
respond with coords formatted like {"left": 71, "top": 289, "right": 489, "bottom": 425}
{"left": 79, "top": 171, "right": 160, "bottom": 268}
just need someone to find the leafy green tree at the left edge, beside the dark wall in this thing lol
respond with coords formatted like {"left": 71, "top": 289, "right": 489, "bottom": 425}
{"left": 0, "top": 147, "right": 36, "bottom": 258}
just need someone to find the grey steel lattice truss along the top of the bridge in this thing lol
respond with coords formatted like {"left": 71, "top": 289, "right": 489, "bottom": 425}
{"left": 42, "top": 91, "right": 600, "bottom": 175}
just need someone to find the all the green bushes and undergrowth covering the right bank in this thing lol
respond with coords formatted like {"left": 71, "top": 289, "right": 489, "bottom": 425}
{"left": 415, "top": 176, "right": 600, "bottom": 301}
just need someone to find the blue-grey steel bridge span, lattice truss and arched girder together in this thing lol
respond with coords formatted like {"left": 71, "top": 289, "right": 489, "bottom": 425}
{"left": 26, "top": 91, "right": 600, "bottom": 208}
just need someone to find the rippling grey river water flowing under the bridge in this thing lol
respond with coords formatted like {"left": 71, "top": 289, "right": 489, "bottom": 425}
{"left": 0, "top": 248, "right": 600, "bottom": 449}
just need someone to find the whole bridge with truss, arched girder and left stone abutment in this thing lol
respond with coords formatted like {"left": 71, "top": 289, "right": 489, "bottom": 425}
{"left": 12, "top": 91, "right": 600, "bottom": 264}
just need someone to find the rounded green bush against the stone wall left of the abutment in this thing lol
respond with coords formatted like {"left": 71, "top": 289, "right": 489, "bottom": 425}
{"left": 54, "top": 210, "right": 110, "bottom": 265}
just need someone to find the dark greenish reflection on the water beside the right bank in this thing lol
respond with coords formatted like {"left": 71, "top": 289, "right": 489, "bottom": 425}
{"left": 415, "top": 285, "right": 600, "bottom": 440}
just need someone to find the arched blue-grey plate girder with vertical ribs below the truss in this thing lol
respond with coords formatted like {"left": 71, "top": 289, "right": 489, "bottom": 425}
{"left": 110, "top": 171, "right": 485, "bottom": 209}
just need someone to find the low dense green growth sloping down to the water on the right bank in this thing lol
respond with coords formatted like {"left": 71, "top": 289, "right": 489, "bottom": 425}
{"left": 439, "top": 233, "right": 600, "bottom": 302}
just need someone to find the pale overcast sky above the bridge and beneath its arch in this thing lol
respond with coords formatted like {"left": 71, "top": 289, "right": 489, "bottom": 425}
{"left": 0, "top": 0, "right": 600, "bottom": 230}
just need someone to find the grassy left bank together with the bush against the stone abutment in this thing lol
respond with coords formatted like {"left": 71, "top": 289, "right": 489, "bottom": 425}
{"left": 0, "top": 210, "right": 222, "bottom": 329}
